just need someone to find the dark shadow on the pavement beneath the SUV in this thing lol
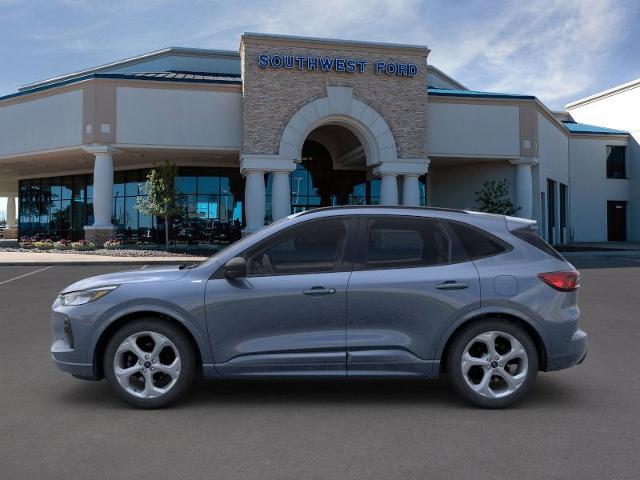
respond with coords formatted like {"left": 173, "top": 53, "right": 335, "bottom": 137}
{"left": 60, "top": 374, "right": 581, "bottom": 409}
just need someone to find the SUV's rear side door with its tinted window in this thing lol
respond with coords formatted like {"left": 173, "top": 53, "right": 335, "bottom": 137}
{"left": 347, "top": 216, "right": 480, "bottom": 376}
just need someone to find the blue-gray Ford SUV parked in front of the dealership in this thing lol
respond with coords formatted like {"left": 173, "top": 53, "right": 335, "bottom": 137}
{"left": 51, "top": 207, "right": 587, "bottom": 408}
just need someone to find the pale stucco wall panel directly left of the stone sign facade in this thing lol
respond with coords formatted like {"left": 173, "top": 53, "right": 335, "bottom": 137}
{"left": 116, "top": 87, "right": 242, "bottom": 150}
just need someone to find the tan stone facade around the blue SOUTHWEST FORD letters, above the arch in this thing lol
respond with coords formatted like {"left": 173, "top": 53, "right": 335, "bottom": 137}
{"left": 241, "top": 37, "right": 427, "bottom": 159}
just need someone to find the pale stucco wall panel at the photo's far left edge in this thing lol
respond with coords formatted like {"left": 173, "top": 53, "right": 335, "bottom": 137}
{"left": 0, "top": 90, "right": 82, "bottom": 156}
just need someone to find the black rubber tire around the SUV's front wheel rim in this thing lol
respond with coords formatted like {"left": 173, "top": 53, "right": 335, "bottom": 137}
{"left": 102, "top": 318, "right": 196, "bottom": 409}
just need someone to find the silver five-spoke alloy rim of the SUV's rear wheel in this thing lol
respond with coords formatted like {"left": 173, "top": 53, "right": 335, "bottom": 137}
{"left": 461, "top": 331, "right": 529, "bottom": 398}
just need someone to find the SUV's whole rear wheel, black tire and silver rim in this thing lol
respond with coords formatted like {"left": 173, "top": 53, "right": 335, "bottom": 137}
{"left": 446, "top": 319, "right": 538, "bottom": 408}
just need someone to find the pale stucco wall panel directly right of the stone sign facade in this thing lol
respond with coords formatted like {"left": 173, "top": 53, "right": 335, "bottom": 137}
{"left": 427, "top": 102, "right": 520, "bottom": 157}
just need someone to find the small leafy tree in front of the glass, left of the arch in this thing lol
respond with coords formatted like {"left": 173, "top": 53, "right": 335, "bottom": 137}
{"left": 136, "top": 160, "right": 178, "bottom": 250}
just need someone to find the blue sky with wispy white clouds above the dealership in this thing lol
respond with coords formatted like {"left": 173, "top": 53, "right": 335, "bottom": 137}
{"left": 0, "top": 0, "right": 640, "bottom": 109}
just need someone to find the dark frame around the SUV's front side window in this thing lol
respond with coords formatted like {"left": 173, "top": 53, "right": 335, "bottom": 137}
{"left": 212, "top": 215, "right": 357, "bottom": 279}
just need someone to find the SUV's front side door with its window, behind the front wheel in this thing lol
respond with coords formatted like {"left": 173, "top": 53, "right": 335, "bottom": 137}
{"left": 205, "top": 218, "right": 351, "bottom": 376}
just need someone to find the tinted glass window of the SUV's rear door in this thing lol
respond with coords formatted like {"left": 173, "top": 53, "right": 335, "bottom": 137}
{"left": 364, "top": 217, "right": 451, "bottom": 269}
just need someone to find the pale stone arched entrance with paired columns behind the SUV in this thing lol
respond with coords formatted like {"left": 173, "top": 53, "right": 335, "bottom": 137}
{"left": 240, "top": 86, "right": 428, "bottom": 232}
